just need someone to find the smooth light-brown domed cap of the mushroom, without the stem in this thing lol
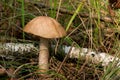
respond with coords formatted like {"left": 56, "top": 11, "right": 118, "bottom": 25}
{"left": 23, "top": 16, "right": 66, "bottom": 38}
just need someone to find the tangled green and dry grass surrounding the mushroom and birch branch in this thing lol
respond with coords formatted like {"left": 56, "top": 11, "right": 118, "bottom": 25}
{"left": 0, "top": 0, "right": 120, "bottom": 80}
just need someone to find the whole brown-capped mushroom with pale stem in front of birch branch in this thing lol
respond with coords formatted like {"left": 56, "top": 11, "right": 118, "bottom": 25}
{"left": 23, "top": 16, "right": 66, "bottom": 72}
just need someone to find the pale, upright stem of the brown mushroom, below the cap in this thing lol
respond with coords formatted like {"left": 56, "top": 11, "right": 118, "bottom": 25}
{"left": 38, "top": 38, "right": 49, "bottom": 72}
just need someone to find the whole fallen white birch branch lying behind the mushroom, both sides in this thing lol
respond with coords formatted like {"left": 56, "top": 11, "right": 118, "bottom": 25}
{"left": 0, "top": 43, "right": 120, "bottom": 66}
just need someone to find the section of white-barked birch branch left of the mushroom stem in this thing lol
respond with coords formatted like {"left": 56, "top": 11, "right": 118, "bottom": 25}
{"left": 0, "top": 43, "right": 38, "bottom": 59}
